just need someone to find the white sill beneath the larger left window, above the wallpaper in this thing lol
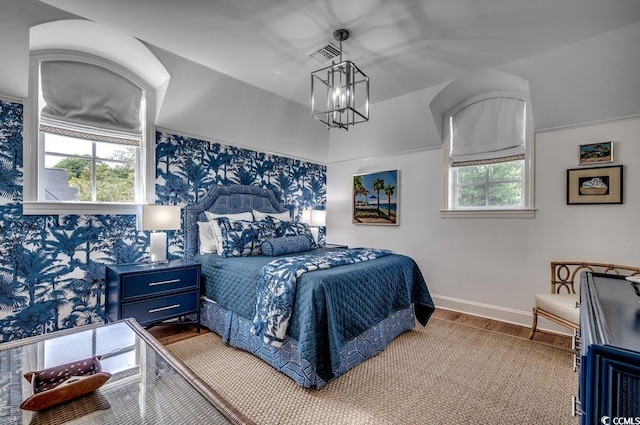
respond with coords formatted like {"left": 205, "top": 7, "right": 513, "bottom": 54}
{"left": 22, "top": 202, "right": 138, "bottom": 215}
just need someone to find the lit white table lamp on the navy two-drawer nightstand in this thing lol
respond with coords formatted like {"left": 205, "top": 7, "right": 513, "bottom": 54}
{"left": 142, "top": 205, "right": 180, "bottom": 263}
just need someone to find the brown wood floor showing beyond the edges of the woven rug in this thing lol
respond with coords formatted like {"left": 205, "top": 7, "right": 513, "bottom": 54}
{"left": 149, "top": 308, "right": 571, "bottom": 350}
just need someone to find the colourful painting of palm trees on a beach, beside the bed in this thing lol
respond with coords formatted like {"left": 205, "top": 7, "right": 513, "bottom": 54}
{"left": 352, "top": 170, "right": 400, "bottom": 225}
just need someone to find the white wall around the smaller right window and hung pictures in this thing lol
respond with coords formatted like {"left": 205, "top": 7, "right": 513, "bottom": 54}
{"left": 327, "top": 24, "right": 640, "bottom": 330}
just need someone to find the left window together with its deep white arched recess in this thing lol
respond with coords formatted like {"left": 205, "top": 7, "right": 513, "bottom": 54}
{"left": 22, "top": 19, "right": 171, "bottom": 215}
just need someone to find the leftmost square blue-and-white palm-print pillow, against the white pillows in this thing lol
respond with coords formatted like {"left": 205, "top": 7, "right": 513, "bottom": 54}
{"left": 216, "top": 217, "right": 276, "bottom": 257}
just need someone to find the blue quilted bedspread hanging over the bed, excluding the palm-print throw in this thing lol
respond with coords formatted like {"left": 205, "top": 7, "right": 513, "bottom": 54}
{"left": 195, "top": 245, "right": 434, "bottom": 381}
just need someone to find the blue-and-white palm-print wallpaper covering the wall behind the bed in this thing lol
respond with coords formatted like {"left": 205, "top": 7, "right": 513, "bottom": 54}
{"left": 0, "top": 100, "right": 326, "bottom": 342}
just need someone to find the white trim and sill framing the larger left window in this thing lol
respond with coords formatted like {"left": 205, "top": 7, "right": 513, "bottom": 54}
{"left": 23, "top": 50, "right": 156, "bottom": 215}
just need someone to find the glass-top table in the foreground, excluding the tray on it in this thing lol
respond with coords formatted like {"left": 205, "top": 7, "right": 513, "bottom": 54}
{"left": 0, "top": 319, "right": 250, "bottom": 425}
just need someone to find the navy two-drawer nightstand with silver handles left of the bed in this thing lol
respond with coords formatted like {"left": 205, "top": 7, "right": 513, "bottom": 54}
{"left": 105, "top": 259, "right": 200, "bottom": 332}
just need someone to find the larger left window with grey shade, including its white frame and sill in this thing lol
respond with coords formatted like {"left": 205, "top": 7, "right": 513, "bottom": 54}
{"left": 24, "top": 51, "right": 155, "bottom": 214}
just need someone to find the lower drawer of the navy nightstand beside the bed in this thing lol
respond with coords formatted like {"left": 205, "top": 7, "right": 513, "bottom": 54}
{"left": 122, "top": 291, "right": 199, "bottom": 325}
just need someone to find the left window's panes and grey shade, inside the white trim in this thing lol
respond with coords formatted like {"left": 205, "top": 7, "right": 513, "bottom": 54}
{"left": 38, "top": 60, "right": 144, "bottom": 204}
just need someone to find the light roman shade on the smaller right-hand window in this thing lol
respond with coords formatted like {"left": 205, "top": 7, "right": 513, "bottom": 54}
{"left": 450, "top": 97, "right": 526, "bottom": 167}
